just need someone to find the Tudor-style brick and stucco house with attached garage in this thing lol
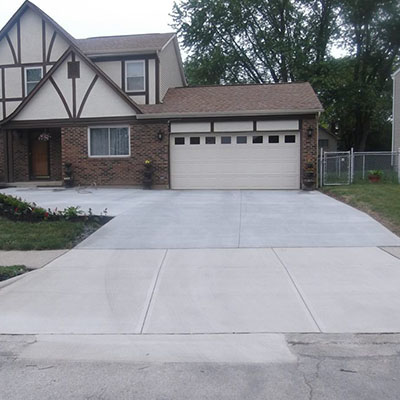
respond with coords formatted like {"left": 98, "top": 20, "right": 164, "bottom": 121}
{"left": 0, "top": 1, "right": 322, "bottom": 189}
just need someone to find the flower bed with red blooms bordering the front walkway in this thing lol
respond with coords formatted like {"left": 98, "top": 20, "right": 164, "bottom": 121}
{"left": 0, "top": 193, "right": 110, "bottom": 224}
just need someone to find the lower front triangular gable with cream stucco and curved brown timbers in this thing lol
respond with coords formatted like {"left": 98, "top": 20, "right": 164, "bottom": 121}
{"left": 2, "top": 47, "right": 141, "bottom": 124}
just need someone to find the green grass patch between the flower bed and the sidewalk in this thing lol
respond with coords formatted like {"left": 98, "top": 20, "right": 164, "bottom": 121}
{"left": 0, "top": 217, "right": 100, "bottom": 250}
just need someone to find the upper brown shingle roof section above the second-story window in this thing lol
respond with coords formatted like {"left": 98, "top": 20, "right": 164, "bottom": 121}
{"left": 76, "top": 33, "right": 174, "bottom": 55}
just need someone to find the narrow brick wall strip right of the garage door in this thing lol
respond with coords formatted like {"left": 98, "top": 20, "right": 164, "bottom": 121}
{"left": 301, "top": 115, "right": 318, "bottom": 187}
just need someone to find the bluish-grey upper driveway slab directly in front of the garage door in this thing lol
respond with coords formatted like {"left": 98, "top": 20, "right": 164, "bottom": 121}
{"left": 78, "top": 190, "right": 400, "bottom": 249}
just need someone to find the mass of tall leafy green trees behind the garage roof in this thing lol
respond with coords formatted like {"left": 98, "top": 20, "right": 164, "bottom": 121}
{"left": 172, "top": 0, "right": 400, "bottom": 150}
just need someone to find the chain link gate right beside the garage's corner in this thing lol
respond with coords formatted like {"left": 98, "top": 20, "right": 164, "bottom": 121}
{"left": 321, "top": 151, "right": 352, "bottom": 186}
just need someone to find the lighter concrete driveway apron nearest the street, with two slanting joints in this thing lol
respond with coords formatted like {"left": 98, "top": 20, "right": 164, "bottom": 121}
{"left": 0, "top": 248, "right": 400, "bottom": 337}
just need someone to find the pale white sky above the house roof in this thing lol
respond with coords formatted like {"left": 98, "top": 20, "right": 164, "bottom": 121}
{"left": 0, "top": 0, "right": 174, "bottom": 39}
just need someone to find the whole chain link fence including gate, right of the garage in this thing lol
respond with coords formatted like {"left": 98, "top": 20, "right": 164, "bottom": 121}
{"left": 319, "top": 149, "right": 400, "bottom": 186}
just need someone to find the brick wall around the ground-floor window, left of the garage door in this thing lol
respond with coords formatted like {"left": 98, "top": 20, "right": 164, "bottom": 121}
{"left": 61, "top": 123, "right": 169, "bottom": 187}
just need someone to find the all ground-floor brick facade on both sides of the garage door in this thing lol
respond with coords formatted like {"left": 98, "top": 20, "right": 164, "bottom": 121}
{"left": 0, "top": 115, "right": 318, "bottom": 188}
